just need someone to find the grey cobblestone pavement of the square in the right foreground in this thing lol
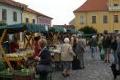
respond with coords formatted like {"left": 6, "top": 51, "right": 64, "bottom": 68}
{"left": 52, "top": 47, "right": 120, "bottom": 80}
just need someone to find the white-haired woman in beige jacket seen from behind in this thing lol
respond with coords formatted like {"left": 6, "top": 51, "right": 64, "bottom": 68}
{"left": 61, "top": 38, "right": 75, "bottom": 77}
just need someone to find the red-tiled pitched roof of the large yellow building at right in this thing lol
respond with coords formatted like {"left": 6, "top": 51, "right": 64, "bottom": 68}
{"left": 74, "top": 0, "right": 108, "bottom": 13}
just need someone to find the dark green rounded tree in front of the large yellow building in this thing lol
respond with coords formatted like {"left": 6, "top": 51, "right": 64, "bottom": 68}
{"left": 79, "top": 26, "right": 97, "bottom": 34}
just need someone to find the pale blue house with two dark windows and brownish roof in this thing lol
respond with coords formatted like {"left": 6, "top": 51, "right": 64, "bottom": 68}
{"left": 0, "top": 0, "right": 25, "bottom": 25}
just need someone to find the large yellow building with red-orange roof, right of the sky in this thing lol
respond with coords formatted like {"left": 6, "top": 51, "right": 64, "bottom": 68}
{"left": 73, "top": 0, "right": 120, "bottom": 33}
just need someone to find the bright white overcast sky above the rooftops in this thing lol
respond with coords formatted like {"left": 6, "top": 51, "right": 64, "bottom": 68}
{"left": 15, "top": 0, "right": 86, "bottom": 25}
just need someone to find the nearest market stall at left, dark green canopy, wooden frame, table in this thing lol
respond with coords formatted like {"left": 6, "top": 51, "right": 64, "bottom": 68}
{"left": 0, "top": 24, "right": 33, "bottom": 69}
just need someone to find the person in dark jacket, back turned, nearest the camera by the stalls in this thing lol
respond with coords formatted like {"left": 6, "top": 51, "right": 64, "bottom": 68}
{"left": 36, "top": 39, "right": 52, "bottom": 80}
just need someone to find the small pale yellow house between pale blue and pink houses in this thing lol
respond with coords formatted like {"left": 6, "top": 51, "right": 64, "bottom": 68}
{"left": 22, "top": 8, "right": 39, "bottom": 24}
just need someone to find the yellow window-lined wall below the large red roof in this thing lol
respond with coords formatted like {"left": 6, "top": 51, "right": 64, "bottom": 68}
{"left": 74, "top": 12, "right": 120, "bottom": 32}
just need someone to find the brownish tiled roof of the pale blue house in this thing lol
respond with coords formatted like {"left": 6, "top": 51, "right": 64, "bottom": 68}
{"left": 0, "top": 0, "right": 27, "bottom": 9}
